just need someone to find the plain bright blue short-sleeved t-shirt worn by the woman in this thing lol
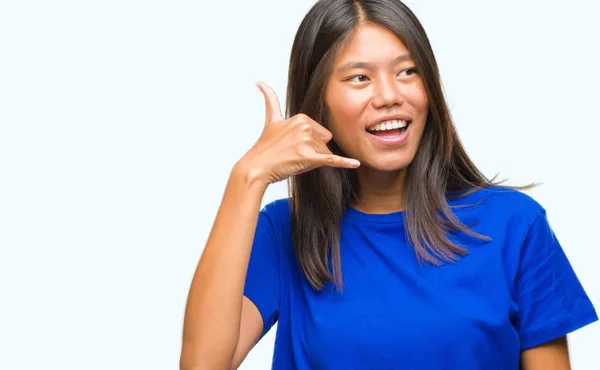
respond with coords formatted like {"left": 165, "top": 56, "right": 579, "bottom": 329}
{"left": 244, "top": 187, "right": 598, "bottom": 370}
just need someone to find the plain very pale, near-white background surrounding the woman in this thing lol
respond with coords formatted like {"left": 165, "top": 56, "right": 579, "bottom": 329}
{"left": 0, "top": 0, "right": 600, "bottom": 370}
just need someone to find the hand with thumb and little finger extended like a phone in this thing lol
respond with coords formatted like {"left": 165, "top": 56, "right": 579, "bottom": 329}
{"left": 240, "top": 83, "right": 360, "bottom": 186}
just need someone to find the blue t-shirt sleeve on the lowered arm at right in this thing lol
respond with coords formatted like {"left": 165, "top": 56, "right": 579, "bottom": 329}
{"left": 515, "top": 210, "right": 598, "bottom": 350}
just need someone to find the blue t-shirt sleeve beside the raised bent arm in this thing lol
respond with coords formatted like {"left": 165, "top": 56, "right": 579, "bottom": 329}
{"left": 244, "top": 204, "right": 279, "bottom": 338}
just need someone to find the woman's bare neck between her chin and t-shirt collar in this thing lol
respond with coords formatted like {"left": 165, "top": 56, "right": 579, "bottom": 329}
{"left": 352, "top": 167, "right": 406, "bottom": 214}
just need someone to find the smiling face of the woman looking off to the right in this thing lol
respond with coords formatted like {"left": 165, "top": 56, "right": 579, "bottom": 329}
{"left": 325, "top": 24, "right": 428, "bottom": 171}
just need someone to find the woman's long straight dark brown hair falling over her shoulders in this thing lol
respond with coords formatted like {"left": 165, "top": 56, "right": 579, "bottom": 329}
{"left": 286, "top": 0, "right": 535, "bottom": 290}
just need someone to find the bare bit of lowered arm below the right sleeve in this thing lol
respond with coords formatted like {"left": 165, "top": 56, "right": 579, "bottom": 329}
{"left": 520, "top": 336, "right": 571, "bottom": 370}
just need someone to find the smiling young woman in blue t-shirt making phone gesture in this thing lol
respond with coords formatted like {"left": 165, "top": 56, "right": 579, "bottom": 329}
{"left": 180, "top": 0, "right": 597, "bottom": 370}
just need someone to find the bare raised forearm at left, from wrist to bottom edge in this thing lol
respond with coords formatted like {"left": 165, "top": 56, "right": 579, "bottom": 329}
{"left": 180, "top": 164, "right": 266, "bottom": 369}
